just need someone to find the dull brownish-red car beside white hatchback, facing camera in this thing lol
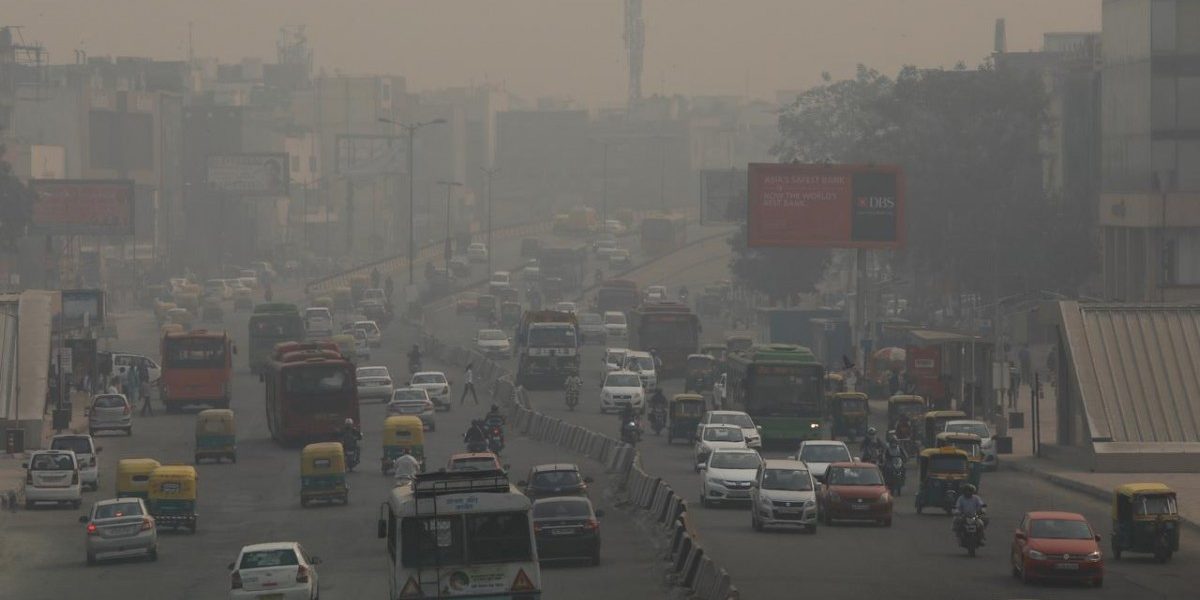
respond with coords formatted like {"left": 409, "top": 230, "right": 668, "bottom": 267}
{"left": 817, "top": 462, "right": 892, "bottom": 527}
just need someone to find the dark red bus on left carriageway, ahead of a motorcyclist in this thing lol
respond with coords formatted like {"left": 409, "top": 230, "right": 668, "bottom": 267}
{"left": 260, "top": 342, "right": 361, "bottom": 445}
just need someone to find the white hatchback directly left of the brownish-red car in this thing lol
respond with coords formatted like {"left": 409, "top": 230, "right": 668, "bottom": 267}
{"left": 750, "top": 458, "right": 817, "bottom": 533}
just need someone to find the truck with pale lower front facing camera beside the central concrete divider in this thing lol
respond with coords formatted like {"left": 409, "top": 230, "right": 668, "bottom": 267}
{"left": 516, "top": 311, "right": 580, "bottom": 389}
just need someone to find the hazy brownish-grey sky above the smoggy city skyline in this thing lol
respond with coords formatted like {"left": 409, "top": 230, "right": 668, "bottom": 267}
{"left": 7, "top": 0, "right": 1100, "bottom": 104}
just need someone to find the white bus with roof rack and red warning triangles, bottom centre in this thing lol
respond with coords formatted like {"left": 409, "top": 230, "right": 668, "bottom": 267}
{"left": 377, "top": 470, "right": 541, "bottom": 600}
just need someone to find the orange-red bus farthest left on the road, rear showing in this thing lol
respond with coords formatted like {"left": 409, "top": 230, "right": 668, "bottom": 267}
{"left": 158, "top": 329, "right": 236, "bottom": 412}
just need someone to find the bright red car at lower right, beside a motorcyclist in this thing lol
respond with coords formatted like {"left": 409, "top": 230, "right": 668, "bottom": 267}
{"left": 1012, "top": 511, "right": 1104, "bottom": 587}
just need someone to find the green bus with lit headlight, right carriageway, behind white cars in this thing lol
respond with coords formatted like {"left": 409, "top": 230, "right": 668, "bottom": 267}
{"left": 725, "top": 344, "right": 824, "bottom": 449}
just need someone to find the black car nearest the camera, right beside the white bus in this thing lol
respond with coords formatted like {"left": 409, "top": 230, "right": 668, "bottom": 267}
{"left": 533, "top": 496, "right": 604, "bottom": 565}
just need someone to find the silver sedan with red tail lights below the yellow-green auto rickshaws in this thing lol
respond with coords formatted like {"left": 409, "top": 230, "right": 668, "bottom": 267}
{"left": 79, "top": 498, "right": 158, "bottom": 565}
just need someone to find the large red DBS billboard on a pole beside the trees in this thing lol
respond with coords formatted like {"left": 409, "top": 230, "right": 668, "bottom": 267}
{"left": 746, "top": 163, "right": 904, "bottom": 248}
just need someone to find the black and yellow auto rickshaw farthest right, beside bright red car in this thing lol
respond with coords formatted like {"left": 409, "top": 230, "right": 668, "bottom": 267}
{"left": 1112, "top": 484, "right": 1180, "bottom": 563}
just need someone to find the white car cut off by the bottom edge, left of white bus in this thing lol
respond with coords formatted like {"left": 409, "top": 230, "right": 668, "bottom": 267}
{"left": 229, "top": 541, "right": 320, "bottom": 600}
